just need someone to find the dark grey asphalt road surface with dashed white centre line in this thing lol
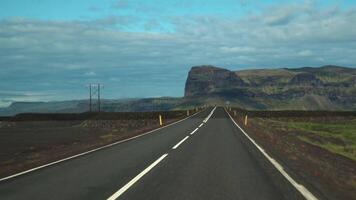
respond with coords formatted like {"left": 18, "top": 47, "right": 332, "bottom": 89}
{"left": 0, "top": 108, "right": 283, "bottom": 200}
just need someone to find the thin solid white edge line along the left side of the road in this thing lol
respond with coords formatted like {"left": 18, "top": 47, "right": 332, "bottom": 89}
{"left": 0, "top": 110, "right": 203, "bottom": 182}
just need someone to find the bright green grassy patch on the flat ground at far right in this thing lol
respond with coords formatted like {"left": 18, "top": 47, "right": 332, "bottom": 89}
{"left": 272, "top": 119, "right": 356, "bottom": 160}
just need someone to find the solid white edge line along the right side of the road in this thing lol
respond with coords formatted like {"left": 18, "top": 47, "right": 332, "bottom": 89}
{"left": 225, "top": 109, "right": 318, "bottom": 200}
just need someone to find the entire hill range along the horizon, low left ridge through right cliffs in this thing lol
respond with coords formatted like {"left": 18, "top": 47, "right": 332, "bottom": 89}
{"left": 0, "top": 65, "right": 356, "bottom": 116}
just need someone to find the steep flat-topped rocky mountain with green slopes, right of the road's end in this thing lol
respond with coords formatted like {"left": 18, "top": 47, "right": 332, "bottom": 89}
{"left": 185, "top": 65, "right": 356, "bottom": 110}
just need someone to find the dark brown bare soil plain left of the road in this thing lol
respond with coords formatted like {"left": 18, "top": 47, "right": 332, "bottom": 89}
{"left": 0, "top": 111, "right": 192, "bottom": 177}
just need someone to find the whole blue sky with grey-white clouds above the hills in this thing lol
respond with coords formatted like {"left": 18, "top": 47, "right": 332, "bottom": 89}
{"left": 0, "top": 0, "right": 356, "bottom": 107}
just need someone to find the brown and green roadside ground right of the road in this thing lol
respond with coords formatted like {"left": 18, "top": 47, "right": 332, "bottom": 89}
{"left": 228, "top": 108, "right": 356, "bottom": 199}
